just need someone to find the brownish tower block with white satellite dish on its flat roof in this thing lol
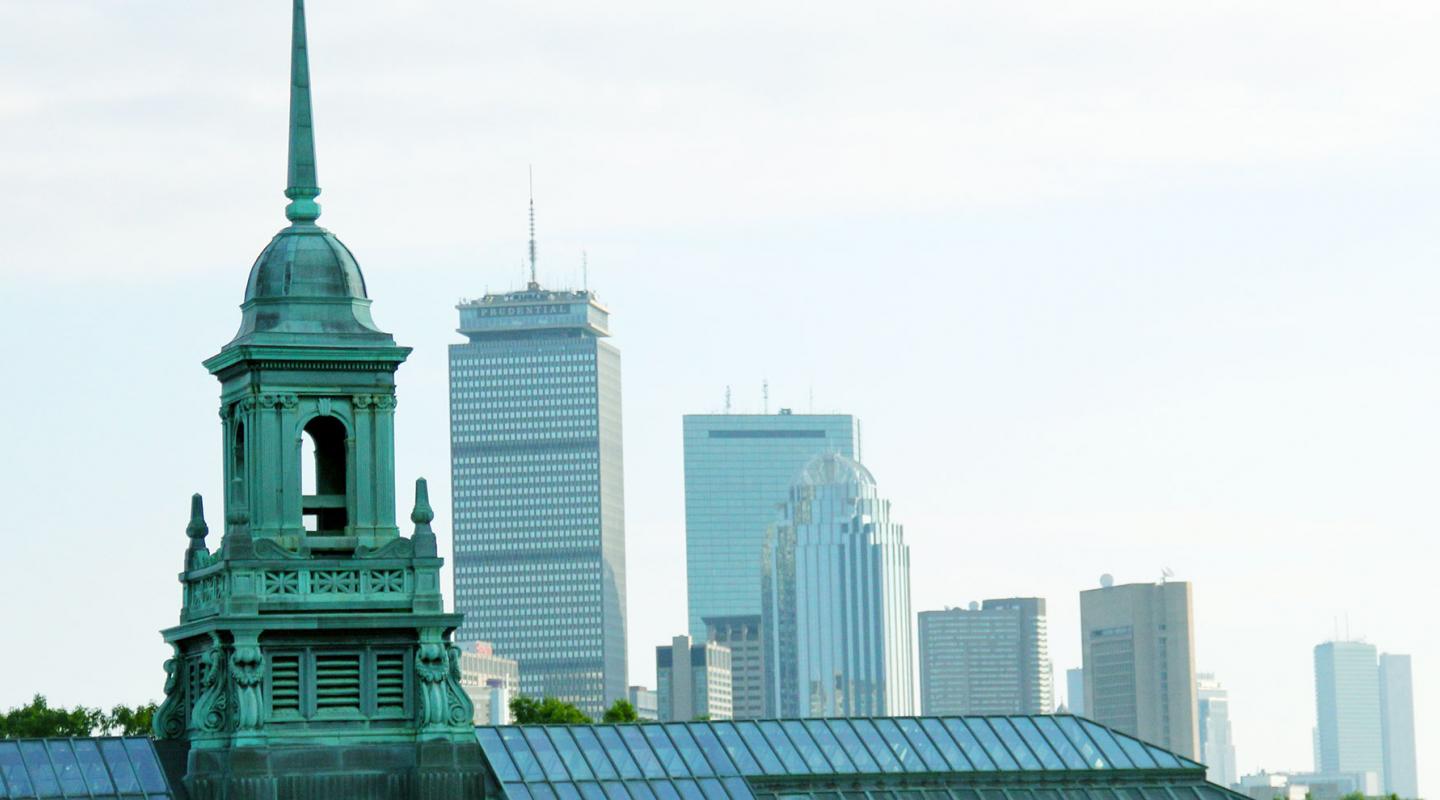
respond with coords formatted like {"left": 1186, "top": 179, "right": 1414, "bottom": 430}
{"left": 1080, "top": 576, "right": 1200, "bottom": 758}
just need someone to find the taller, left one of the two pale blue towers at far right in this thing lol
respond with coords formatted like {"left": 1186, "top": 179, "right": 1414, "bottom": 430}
{"left": 1315, "top": 642, "right": 1385, "bottom": 781}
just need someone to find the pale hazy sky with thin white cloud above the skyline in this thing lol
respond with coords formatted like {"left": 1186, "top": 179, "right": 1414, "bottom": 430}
{"left": 0, "top": 0, "right": 1440, "bottom": 786}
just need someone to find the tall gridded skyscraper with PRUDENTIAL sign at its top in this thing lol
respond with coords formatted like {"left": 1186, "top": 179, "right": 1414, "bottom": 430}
{"left": 449, "top": 282, "right": 626, "bottom": 715}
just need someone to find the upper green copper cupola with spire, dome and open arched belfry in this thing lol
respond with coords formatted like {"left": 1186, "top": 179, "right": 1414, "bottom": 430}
{"left": 206, "top": 0, "right": 409, "bottom": 550}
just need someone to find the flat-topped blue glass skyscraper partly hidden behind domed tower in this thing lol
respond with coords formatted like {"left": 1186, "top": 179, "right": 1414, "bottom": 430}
{"left": 684, "top": 409, "right": 860, "bottom": 640}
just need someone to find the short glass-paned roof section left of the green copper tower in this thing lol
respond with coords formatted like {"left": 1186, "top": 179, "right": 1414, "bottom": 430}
{"left": 0, "top": 737, "right": 171, "bottom": 800}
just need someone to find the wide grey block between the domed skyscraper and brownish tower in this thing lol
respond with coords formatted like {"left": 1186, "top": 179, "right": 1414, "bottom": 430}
{"left": 919, "top": 597, "right": 1056, "bottom": 717}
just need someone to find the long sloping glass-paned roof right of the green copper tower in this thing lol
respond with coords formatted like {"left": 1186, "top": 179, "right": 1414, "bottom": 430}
{"left": 477, "top": 715, "right": 1243, "bottom": 800}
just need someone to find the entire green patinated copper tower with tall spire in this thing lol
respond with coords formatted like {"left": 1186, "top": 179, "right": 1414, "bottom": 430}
{"left": 154, "top": 0, "right": 480, "bottom": 797}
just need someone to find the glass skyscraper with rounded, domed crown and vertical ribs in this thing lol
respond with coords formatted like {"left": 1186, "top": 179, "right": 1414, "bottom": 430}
{"left": 762, "top": 453, "right": 914, "bottom": 717}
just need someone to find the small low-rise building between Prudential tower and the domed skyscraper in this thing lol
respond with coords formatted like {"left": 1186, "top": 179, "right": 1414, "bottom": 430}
{"left": 655, "top": 636, "right": 732, "bottom": 722}
